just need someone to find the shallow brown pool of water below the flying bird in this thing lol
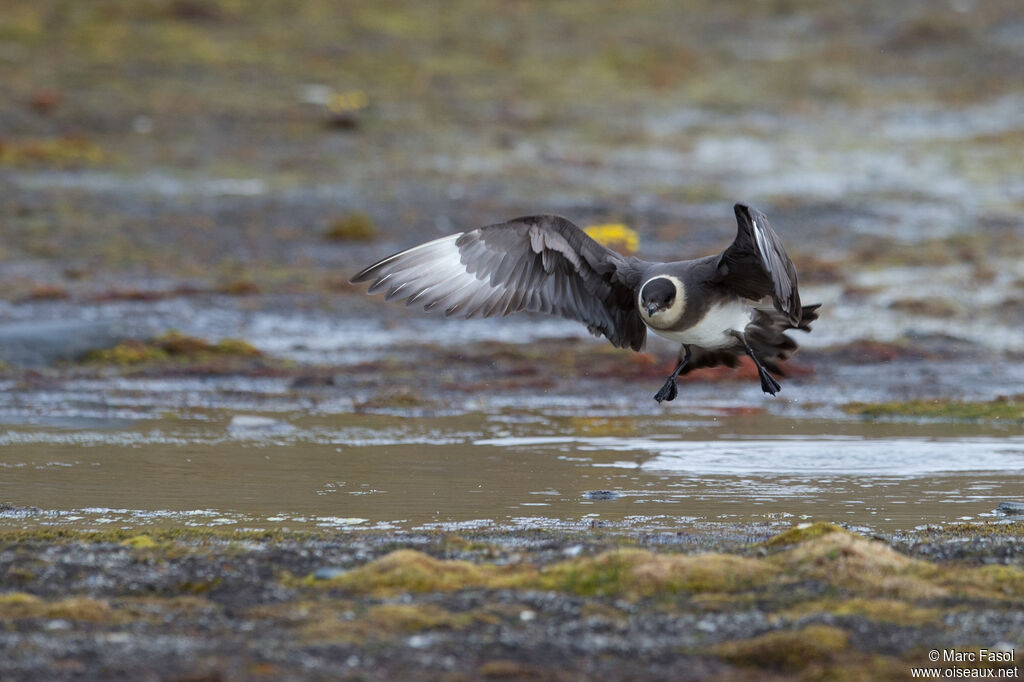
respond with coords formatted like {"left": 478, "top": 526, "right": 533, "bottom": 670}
{"left": 0, "top": 413, "right": 1024, "bottom": 529}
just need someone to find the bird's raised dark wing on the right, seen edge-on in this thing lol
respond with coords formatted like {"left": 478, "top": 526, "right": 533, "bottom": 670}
{"left": 718, "top": 204, "right": 801, "bottom": 327}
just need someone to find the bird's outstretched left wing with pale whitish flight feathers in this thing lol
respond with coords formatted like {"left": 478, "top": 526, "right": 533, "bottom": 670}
{"left": 352, "top": 215, "right": 647, "bottom": 350}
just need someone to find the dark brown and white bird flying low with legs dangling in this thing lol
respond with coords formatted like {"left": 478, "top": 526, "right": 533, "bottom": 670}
{"left": 351, "top": 204, "right": 820, "bottom": 402}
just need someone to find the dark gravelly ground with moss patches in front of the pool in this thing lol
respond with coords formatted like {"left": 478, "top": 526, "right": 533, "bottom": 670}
{"left": 0, "top": 523, "right": 1024, "bottom": 680}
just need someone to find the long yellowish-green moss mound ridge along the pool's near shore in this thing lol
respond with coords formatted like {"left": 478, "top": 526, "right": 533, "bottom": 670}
{"left": 286, "top": 523, "right": 1024, "bottom": 602}
